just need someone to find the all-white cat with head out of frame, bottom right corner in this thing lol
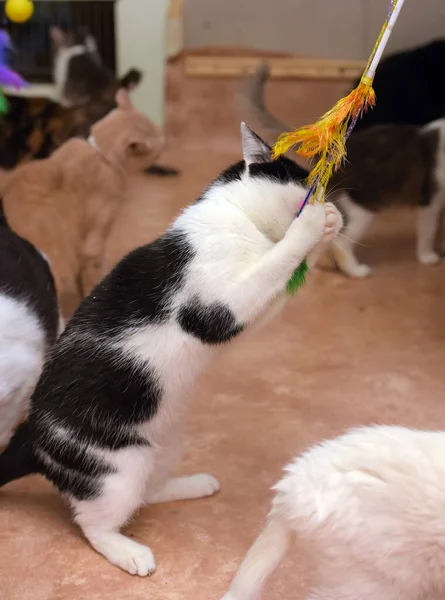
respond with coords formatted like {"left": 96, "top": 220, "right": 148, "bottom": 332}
{"left": 223, "top": 426, "right": 445, "bottom": 600}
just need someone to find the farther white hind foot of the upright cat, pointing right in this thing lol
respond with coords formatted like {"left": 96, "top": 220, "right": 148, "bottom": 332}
{"left": 146, "top": 473, "right": 220, "bottom": 504}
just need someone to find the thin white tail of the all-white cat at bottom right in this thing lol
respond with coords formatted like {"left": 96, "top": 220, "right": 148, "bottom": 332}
{"left": 222, "top": 507, "right": 291, "bottom": 600}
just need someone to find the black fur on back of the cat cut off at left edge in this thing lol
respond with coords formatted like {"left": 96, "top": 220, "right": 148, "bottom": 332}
{"left": 0, "top": 200, "right": 59, "bottom": 346}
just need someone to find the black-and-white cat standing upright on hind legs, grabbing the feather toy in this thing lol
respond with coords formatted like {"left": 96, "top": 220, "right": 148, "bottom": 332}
{"left": 0, "top": 124, "right": 342, "bottom": 576}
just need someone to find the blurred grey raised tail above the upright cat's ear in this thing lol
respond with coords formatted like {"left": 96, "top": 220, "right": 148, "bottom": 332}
{"left": 241, "top": 63, "right": 290, "bottom": 138}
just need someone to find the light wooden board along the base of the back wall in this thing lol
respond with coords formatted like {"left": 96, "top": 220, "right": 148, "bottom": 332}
{"left": 184, "top": 55, "right": 365, "bottom": 79}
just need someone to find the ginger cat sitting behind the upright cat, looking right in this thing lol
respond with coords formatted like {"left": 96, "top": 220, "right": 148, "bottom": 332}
{"left": 3, "top": 89, "right": 164, "bottom": 315}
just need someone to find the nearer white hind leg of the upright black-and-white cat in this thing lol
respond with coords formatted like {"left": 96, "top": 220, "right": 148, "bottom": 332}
{"left": 71, "top": 448, "right": 156, "bottom": 577}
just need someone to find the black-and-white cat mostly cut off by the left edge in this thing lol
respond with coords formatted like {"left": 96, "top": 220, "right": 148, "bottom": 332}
{"left": 0, "top": 202, "right": 59, "bottom": 446}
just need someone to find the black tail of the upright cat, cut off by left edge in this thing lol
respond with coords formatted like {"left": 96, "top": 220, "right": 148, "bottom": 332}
{"left": 0, "top": 421, "right": 40, "bottom": 487}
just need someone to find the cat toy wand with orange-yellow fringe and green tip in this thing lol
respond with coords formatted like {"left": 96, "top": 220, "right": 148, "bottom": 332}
{"left": 272, "top": 0, "right": 405, "bottom": 295}
